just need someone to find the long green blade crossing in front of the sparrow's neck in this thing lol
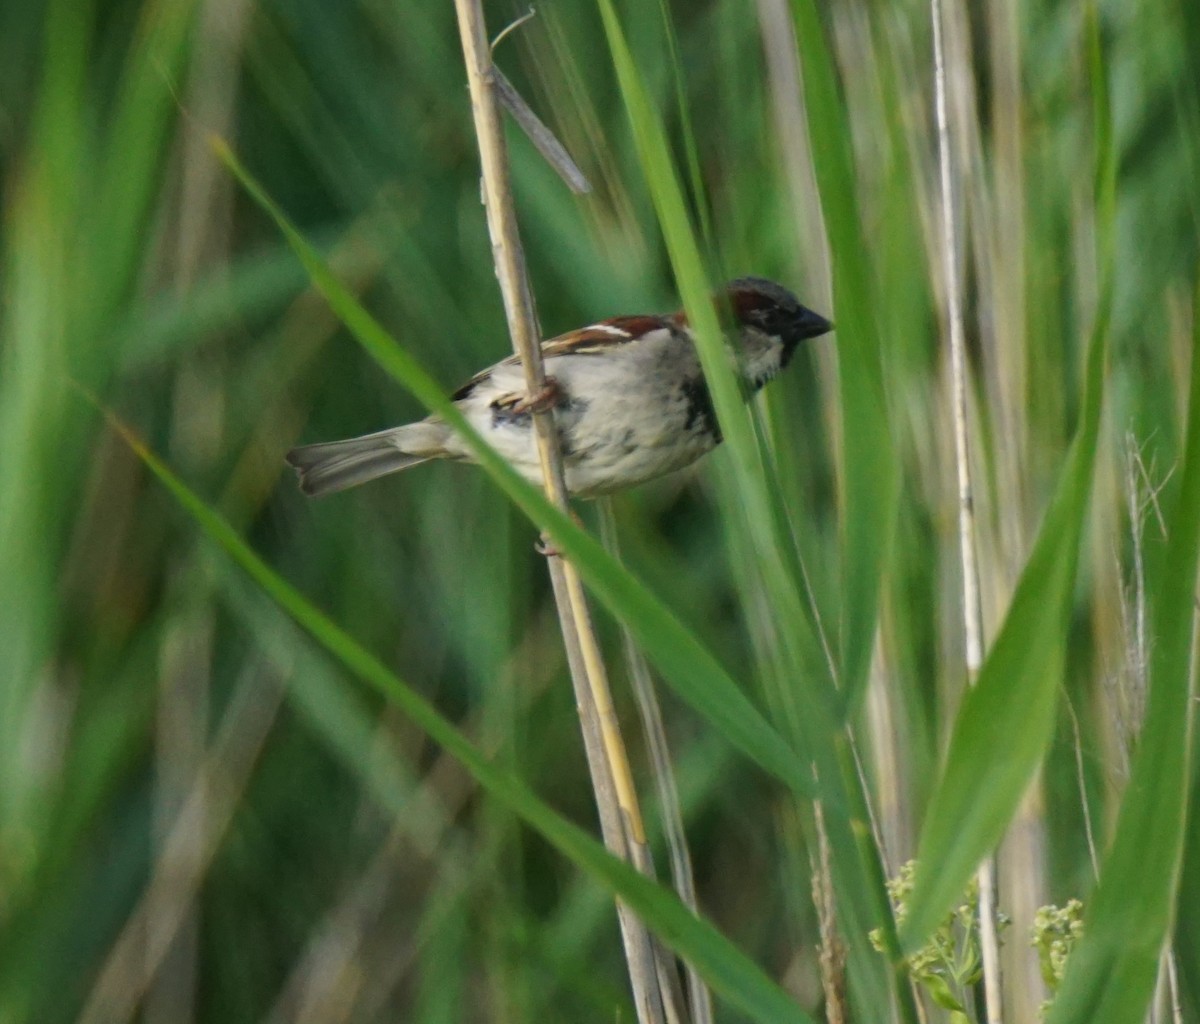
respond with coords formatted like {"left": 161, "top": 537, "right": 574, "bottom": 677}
{"left": 600, "top": 0, "right": 916, "bottom": 1019}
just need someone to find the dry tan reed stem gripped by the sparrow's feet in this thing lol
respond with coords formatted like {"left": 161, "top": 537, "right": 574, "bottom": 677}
{"left": 455, "top": 0, "right": 666, "bottom": 1024}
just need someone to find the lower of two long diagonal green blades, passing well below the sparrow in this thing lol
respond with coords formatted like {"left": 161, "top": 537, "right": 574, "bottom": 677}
{"left": 100, "top": 405, "right": 810, "bottom": 1024}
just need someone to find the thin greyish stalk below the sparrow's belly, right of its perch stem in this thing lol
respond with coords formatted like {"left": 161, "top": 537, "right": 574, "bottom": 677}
{"left": 596, "top": 497, "right": 713, "bottom": 1024}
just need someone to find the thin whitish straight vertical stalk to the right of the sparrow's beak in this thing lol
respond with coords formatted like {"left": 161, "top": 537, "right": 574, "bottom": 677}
{"left": 930, "top": 0, "right": 1004, "bottom": 1024}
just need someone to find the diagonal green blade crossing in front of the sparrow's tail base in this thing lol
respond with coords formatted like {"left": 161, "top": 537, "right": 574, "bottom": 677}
{"left": 214, "top": 140, "right": 814, "bottom": 796}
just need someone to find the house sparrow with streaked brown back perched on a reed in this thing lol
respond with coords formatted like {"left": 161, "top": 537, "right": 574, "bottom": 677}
{"left": 287, "top": 277, "right": 833, "bottom": 497}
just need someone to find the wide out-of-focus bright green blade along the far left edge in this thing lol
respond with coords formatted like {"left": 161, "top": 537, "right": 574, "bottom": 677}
{"left": 0, "top": 0, "right": 92, "bottom": 873}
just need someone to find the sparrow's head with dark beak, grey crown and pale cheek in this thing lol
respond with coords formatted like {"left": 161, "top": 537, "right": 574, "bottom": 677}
{"left": 725, "top": 277, "right": 833, "bottom": 388}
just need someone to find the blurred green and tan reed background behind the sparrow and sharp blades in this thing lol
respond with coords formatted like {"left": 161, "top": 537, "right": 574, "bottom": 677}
{"left": 0, "top": 0, "right": 1200, "bottom": 1024}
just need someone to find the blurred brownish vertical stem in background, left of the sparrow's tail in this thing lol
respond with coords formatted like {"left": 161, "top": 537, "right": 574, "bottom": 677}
{"left": 148, "top": 0, "right": 250, "bottom": 1024}
